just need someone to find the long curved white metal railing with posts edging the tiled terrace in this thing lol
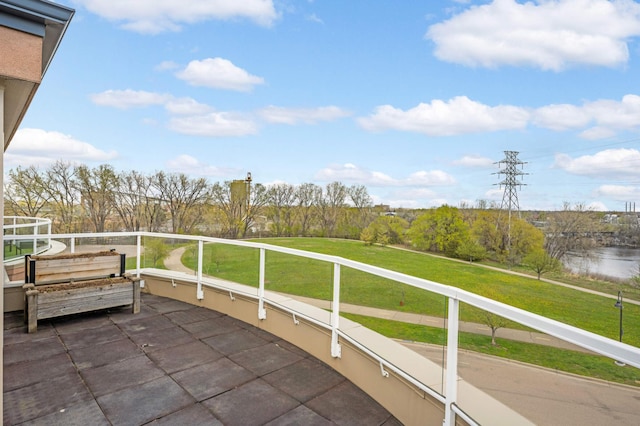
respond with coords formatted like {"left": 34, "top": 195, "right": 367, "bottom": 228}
{"left": 5, "top": 232, "right": 640, "bottom": 425}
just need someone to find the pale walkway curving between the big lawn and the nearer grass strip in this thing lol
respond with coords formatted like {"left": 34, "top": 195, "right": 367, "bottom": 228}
{"left": 164, "top": 247, "right": 590, "bottom": 353}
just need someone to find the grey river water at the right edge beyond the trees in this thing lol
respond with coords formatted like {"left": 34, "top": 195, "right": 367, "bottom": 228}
{"left": 563, "top": 247, "right": 640, "bottom": 279}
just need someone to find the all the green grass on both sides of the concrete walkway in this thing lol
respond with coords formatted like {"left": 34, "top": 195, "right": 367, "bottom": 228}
{"left": 175, "top": 238, "right": 640, "bottom": 386}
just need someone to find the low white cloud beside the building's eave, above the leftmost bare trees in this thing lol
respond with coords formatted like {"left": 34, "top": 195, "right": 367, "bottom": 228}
{"left": 5, "top": 128, "right": 118, "bottom": 168}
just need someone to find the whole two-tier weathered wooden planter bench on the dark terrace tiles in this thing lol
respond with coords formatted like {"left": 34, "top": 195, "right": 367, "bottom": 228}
{"left": 23, "top": 250, "right": 140, "bottom": 333}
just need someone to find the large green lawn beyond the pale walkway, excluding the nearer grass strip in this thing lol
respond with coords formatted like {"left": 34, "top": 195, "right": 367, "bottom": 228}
{"left": 183, "top": 238, "right": 640, "bottom": 346}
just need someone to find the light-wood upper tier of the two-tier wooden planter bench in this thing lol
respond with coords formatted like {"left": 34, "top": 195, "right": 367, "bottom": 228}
{"left": 24, "top": 251, "right": 126, "bottom": 285}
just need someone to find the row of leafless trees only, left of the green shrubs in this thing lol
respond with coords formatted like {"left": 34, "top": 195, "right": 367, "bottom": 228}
{"left": 5, "top": 161, "right": 373, "bottom": 238}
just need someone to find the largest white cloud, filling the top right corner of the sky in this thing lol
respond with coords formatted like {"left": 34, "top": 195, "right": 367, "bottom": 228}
{"left": 425, "top": 0, "right": 640, "bottom": 71}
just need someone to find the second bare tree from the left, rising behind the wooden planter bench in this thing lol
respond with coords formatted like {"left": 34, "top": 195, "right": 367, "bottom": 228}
{"left": 43, "top": 161, "right": 80, "bottom": 232}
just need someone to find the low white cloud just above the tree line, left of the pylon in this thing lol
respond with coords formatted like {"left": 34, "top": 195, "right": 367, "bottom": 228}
{"left": 315, "top": 163, "right": 455, "bottom": 187}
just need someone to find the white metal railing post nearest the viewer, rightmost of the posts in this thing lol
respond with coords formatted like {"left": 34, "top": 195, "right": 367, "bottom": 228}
{"left": 443, "top": 297, "right": 460, "bottom": 426}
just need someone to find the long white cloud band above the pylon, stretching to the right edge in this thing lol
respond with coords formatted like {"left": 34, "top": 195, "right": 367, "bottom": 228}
{"left": 358, "top": 94, "right": 640, "bottom": 139}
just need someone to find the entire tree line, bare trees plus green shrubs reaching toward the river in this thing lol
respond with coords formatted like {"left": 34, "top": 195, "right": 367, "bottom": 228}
{"left": 5, "top": 161, "right": 602, "bottom": 275}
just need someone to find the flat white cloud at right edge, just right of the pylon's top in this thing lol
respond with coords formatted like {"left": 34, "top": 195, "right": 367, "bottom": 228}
{"left": 554, "top": 148, "right": 640, "bottom": 180}
